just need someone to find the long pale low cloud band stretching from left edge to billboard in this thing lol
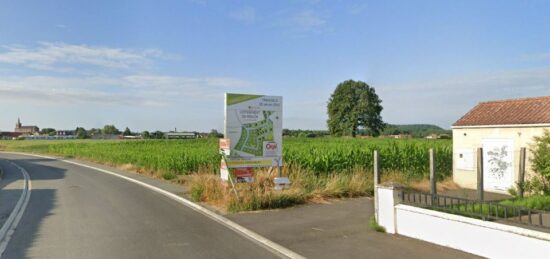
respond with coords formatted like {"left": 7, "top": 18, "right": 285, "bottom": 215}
{"left": 0, "top": 75, "right": 252, "bottom": 106}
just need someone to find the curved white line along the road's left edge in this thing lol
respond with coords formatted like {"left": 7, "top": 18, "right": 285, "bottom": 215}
{"left": 0, "top": 161, "right": 32, "bottom": 257}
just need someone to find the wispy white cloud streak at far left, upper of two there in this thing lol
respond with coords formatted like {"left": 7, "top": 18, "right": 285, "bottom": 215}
{"left": 0, "top": 42, "right": 163, "bottom": 71}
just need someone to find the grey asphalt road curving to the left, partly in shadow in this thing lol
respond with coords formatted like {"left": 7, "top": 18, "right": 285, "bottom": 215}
{"left": 0, "top": 154, "right": 282, "bottom": 258}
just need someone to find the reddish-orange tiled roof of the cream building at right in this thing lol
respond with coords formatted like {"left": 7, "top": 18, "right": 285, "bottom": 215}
{"left": 453, "top": 96, "right": 550, "bottom": 127}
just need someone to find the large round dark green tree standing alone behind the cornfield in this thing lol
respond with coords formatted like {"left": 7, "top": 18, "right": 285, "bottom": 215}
{"left": 327, "top": 80, "right": 385, "bottom": 137}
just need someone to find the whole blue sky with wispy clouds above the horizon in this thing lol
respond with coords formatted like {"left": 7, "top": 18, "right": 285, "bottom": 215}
{"left": 0, "top": 0, "right": 550, "bottom": 131}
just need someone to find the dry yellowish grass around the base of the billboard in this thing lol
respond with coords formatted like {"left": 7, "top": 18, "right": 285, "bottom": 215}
{"left": 186, "top": 166, "right": 386, "bottom": 212}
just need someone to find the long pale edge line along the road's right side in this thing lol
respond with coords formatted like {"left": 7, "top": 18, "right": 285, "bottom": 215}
{"left": 0, "top": 151, "right": 305, "bottom": 259}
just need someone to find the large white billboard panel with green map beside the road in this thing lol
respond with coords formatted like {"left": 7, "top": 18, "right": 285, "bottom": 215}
{"left": 223, "top": 93, "right": 283, "bottom": 172}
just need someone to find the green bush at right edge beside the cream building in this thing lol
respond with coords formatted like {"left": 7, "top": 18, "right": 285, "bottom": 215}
{"left": 525, "top": 130, "right": 550, "bottom": 195}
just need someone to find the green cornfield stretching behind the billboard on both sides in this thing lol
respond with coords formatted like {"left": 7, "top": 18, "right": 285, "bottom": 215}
{"left": 0, "top": 138, "right": 452, "bottom": 181}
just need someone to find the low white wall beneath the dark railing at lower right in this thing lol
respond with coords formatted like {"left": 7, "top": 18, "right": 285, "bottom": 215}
{"left": 396, "top": 203, "right": 550, "bottom": 259}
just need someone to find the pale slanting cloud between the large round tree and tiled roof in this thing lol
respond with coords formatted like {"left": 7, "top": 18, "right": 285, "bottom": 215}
{"left": 373, "top": 67, "right": 550, "bottom": 127}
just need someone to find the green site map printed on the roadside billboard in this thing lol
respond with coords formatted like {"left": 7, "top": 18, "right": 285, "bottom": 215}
{"left": 235, "top": 111, "right": 274, "bottom": 156}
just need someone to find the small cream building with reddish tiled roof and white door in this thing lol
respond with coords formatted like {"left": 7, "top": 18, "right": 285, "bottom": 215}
{"left": 452, "top": 96, "right": 550, "bottom": 192}
